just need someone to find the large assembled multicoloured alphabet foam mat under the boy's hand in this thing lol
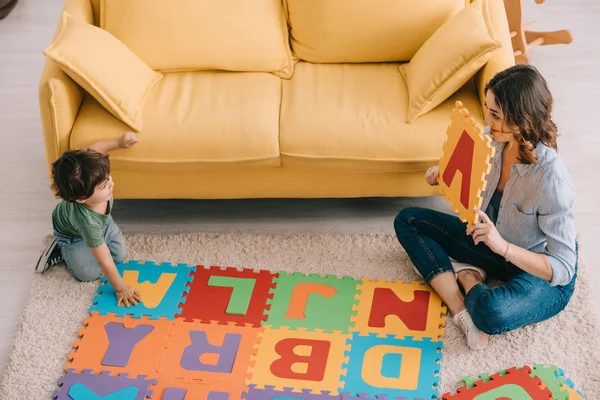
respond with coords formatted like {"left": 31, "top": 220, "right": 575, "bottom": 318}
{"left": 53, "top": 261, "right": 446, "bottom": 400}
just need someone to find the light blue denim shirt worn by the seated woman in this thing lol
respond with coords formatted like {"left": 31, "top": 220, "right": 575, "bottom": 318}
{"left": 481, "top": 127, "right": 577, "bottom": 286}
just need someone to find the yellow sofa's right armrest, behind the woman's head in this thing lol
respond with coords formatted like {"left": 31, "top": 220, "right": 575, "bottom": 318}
{"left": 475, "top": 0, "right": 515, "bottom": 112}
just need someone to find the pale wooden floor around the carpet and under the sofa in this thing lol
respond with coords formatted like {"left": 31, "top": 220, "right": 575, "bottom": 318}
{"left": 0, "top": 0, "right": 600, "bottom": 376}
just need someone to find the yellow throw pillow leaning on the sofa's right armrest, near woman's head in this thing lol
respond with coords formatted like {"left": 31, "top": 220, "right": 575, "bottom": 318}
{"left": 398, "top": 0, "right": 501, "bottom": 123}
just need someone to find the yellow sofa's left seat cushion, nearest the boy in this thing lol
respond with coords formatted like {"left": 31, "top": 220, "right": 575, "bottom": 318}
{"left": 70, "top": 71, "right": 281, "bottom": 172}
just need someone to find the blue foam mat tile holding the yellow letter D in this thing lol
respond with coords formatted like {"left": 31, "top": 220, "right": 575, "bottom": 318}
{"left": 342, "top": 333, "right": 442, "bottom": 399}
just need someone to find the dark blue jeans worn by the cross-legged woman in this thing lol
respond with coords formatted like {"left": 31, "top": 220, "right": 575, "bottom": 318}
{"left": 394, "top": 208, "right": 577, "bottom": 334}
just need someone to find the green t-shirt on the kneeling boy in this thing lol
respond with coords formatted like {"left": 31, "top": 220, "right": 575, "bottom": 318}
{"left": 52, "top": 197, "right": 113, "bottom": 248}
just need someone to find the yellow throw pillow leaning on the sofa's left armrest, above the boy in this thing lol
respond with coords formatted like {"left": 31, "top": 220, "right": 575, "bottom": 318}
{"left": 44, "top": 13, "right": 163, "bottom": 132}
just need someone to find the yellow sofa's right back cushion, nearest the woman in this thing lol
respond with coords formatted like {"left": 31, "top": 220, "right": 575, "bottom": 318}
{"left": 284, "top": 0, "right": 469, "bottom": 63}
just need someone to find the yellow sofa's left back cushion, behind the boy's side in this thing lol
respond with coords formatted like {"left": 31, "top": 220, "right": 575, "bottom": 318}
{"left": 100, "top": 0, "right": 293, "bottom": 78}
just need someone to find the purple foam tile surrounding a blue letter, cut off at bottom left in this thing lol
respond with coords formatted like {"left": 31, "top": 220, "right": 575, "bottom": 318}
{"left": 52, "top": 369, "right": 157, "bottom": 400}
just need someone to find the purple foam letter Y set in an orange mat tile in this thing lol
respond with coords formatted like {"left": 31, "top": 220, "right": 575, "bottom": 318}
{"left": 102, "top": 322, "right": 154, "bottom": 367}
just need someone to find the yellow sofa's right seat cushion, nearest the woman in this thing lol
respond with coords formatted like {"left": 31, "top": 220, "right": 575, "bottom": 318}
{"left": 280, "top": 62, "right": 482, "bottom": 172}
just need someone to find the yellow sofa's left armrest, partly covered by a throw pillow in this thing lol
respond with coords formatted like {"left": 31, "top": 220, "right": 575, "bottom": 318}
{"left": 38, "top": 0, "right": 94, "bottom": 174}
